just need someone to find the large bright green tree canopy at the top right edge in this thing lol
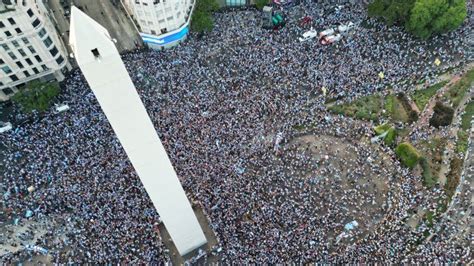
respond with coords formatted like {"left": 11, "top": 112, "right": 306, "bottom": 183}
{"left": 367, "top": 0, "right": 467, "bottom": 39}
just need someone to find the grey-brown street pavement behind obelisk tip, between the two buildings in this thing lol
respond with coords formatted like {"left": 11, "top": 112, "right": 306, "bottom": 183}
{"left": 45, "top": 0, "right": 143, "bottom": 53}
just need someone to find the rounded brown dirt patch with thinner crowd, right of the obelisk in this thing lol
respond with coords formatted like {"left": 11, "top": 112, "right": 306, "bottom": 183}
{"left": 266, "top": 135, "right": 395, "bottom": 249}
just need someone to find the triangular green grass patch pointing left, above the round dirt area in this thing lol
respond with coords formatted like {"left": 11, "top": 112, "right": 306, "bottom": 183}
{"left": 329, "top": 95, "right": 382, "bottom": 121}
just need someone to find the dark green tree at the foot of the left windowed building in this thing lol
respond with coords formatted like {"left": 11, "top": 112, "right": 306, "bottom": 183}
{"left": 12, "top": 80, "right": 60, "bottom": 113}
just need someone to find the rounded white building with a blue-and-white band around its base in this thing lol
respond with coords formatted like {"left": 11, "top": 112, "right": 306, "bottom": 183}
{"left": 124, "top": 0, "right": 195, "bottom": 49}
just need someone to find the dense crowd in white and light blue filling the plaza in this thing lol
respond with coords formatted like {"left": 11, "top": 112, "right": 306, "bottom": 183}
{"left": 0, "top": 1, "right": 472, "bottom": 263}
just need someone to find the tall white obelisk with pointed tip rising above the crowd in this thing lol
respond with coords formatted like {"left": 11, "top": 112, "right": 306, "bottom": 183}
{"left": 69, "top": 6, "right": 207, "bottom": 255}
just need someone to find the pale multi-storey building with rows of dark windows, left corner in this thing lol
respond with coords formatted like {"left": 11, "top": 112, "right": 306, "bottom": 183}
{"left": 0, "top": 0, "right": 71, "bottom": 101}
